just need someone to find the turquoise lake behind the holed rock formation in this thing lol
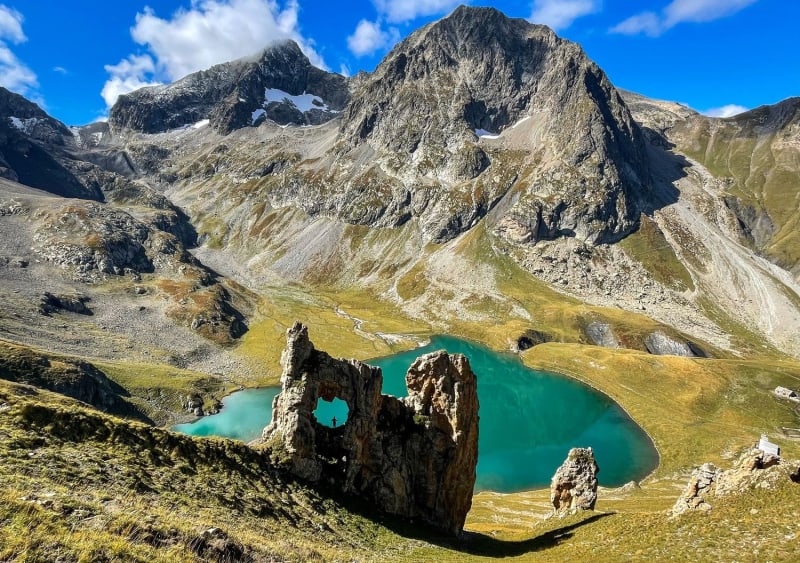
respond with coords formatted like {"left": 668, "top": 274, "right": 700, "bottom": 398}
{"left": 175, "top": 336, "right": 658, "bottom": 492}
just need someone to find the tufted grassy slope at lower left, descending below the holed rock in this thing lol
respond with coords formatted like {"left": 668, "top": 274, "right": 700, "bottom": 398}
{"left": 0, "top": 381, "right": 412, "bottom": 561}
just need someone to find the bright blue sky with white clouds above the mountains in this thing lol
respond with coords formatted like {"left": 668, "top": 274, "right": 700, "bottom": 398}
{"left": 0, "top": 0, "right": 800, "bottom": 125}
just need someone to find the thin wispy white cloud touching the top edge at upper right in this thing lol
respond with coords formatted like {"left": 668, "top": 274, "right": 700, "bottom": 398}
{"left": 610, "top": 0, "right": 758, "bottom": 37}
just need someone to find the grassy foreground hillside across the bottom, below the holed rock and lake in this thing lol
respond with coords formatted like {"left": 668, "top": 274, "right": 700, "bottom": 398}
{"left": 0, "top": 381, "right": 800, "bottom": 562}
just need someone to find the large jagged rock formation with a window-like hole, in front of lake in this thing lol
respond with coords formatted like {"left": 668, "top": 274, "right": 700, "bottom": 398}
{"left": 263, "top": 323, "right": 478, "bottom": 534}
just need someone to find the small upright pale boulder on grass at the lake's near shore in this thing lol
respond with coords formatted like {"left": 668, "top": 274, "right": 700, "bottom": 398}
{"left": 550, "top": 448, "right": 600, "bottom": 514}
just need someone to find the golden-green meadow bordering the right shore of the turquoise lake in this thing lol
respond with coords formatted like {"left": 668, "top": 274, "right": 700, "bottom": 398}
{"left": 522, "top": 344, "right": 800, "bottom": 477}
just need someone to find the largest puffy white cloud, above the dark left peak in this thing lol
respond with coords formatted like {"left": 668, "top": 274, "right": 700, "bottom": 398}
{"left": 102, "top": 0, "right": 327, "bottom": 107}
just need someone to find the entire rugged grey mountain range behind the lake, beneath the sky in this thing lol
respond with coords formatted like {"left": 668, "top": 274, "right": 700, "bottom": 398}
{"left": 0, "top": 7, "right": 800, "bottom": 360}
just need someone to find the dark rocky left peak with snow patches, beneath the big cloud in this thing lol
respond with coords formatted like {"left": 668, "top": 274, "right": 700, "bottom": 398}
{"left": 109, "top": 41, "right": 349, "bottom": 134}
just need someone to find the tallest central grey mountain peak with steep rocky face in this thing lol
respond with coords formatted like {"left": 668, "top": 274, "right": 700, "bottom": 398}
{"left": 342, "top": 7, "right": 649, "bottom": 243}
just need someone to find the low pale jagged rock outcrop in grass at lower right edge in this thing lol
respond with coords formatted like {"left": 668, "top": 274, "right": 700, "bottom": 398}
{"left": 670, "top": 448, "right": 797, "bottom": 516}
